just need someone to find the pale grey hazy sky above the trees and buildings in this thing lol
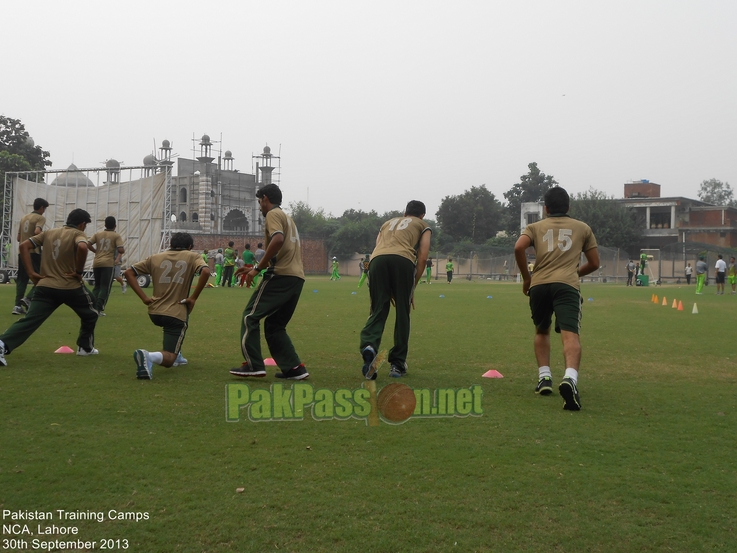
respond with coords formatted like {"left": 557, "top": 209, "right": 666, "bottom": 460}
{"left": 0, "top": 0, "right": 737, "bottom": 218}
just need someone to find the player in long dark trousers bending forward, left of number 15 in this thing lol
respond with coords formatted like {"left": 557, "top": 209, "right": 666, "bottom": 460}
{"left": 359, "top": 200, "right": 432, "bottom": 380}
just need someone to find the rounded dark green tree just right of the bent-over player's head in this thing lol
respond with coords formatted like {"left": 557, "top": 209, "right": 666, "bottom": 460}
{"left": 435, "top": 184, "right": 506, "bottom": 243}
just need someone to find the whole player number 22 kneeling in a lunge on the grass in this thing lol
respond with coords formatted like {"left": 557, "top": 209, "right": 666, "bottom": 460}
{"left": 125, "top": 232, "right": 210, "bottom": 380}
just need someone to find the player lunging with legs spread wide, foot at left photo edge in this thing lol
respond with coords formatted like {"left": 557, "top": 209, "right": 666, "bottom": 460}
{"left": 0, "top": 209, "right": 98, "bottom": 365}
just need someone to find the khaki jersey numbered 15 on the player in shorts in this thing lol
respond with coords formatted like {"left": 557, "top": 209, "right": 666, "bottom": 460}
{"left": 522, "top": 215, "right": 596, "bottom": 290}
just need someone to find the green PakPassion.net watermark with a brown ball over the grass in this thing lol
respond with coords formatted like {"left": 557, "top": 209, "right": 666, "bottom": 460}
{"left": 225, "top": 381, "right": 483, "bottom": 426}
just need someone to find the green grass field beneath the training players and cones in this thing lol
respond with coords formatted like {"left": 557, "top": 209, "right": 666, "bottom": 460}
{"left": 0, "top": 277, "right": 737, "bottom": 552}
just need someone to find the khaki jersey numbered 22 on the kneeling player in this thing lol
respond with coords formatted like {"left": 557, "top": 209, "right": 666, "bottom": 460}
{"left": 131, "top": 250, "right": 207, "bottom": 321}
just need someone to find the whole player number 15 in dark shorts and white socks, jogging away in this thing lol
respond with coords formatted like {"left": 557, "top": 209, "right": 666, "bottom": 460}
{"left": 514, "top": 186, "right": 599, "bottom": 411}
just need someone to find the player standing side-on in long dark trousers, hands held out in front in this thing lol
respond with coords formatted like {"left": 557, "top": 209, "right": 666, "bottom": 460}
{"left": 230, "top": 184, "right": 310, "bottom": 380}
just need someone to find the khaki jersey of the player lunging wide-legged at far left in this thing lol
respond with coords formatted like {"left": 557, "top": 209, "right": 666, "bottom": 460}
{"left": 29, "top": 225, "right": 87, "bottom": 290}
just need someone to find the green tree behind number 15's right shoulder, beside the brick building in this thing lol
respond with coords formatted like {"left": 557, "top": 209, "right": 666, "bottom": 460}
{"left": 568, "top": 188, "right": 642, "bottom": 250}
